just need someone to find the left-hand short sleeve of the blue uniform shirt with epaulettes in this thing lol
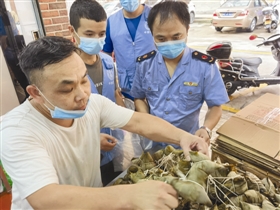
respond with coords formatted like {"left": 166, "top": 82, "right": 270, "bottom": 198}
{"left": 130, "top": 62, "right": 146, "bottom": 99}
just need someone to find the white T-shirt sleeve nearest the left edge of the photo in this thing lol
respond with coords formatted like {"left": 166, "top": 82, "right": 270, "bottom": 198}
{"left": 1, "top": 127, "right": 59, "bottom": 199}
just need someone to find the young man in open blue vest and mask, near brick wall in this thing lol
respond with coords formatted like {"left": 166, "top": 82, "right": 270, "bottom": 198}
{"left": 69, "top": 0, "right": 124, "bottom": 185}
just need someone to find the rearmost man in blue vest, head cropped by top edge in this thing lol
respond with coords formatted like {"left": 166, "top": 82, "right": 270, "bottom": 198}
{"left": 103, "top": 0, "right": 155, "bottom": 99}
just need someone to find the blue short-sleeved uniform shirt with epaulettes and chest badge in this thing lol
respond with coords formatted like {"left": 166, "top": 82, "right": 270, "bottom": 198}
{"left": 131, "top": 47, "right": 228, "bottom": 147}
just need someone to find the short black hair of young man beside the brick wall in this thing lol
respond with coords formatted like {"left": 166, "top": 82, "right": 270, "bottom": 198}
{"left": 69, "top": 0, "right": 107, "bottom": 31}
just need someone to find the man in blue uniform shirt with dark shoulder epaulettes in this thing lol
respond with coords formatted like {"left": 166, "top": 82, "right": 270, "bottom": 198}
{"left": 131, "top": 1, "right": 228, "bottom": 151}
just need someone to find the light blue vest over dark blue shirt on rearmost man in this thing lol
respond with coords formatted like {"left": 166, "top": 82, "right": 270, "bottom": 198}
{"left": 103, "top": 5, "right": 155, "bottom": 95}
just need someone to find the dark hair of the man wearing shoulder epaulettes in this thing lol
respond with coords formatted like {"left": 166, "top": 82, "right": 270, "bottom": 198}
{"left": 148, "top": 0, "right": 190, "bottom": 33}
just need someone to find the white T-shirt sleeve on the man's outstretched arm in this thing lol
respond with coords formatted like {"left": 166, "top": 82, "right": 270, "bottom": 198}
{"left": 100, "top": 96, "right": 134, "bottom": 129}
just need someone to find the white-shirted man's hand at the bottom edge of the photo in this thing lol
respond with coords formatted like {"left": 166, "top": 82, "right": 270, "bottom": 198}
{"left": 126, "top": 181, "right": 178, "bottom": 210}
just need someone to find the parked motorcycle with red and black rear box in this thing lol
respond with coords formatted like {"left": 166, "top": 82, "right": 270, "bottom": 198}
{"left": 206, "top": 34, "right": 280, "bottom": 95}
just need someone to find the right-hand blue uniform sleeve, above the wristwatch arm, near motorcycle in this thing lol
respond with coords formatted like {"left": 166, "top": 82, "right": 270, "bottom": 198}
{"left": 204, "top": 64, "right": 229, "bottom": 107}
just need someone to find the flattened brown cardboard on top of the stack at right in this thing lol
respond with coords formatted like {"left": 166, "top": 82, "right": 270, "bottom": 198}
{"left": 217, "top": 93, "right": 280, "bottom": 162}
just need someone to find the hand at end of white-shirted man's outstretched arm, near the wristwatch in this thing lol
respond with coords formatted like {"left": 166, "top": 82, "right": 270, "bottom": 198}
{"left": 180, "top": 135, "right": 209, "bottom": 160}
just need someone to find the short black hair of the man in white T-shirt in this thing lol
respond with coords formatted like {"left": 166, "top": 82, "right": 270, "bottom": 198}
{"left": 18, "top": 36, "right": 80, "bottom": 86}
